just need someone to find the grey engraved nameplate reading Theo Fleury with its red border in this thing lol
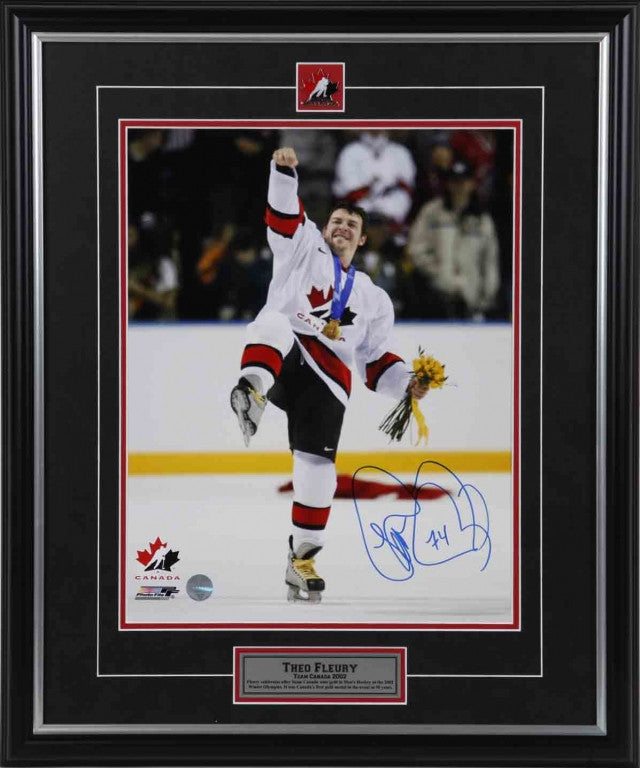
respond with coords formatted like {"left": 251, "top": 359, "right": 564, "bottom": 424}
{"left": 233, "top": 646, "right": 407, "bottom": 704}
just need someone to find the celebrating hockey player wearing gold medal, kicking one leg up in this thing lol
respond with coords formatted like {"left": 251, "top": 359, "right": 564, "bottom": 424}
{"left": 231, "top": 147, "right": 427, "bottom": 603}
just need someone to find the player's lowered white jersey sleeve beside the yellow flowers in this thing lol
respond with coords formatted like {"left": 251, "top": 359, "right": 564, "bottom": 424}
{"left": 356, "top": 288, "right": 412, "bottom": 400}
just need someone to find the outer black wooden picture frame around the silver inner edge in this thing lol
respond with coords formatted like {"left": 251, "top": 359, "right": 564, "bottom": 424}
{"left": 1, "top": 0, "right": 640, "bottom": 768}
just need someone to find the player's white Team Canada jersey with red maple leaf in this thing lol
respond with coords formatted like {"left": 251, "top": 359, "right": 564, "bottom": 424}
{"left": 256, "top": 161, "right": 412, "bottom": 405}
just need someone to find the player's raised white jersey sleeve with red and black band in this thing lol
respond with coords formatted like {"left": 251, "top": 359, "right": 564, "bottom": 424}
{"left": 264, "top": 160, "right": 318, "bottom": 275}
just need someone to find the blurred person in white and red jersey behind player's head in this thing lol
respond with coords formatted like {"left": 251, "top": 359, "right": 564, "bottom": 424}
{"left": 333, "top": 130, "right": 416, "bottom": 304}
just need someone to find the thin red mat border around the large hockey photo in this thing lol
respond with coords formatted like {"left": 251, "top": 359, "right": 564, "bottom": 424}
{"left": 118, "top": 118, "right": 522, "bottom": 631}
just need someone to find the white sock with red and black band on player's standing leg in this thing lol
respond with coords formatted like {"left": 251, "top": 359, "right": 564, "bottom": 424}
{"left": 291, "top": 451, "right": 336, "bottom": 552}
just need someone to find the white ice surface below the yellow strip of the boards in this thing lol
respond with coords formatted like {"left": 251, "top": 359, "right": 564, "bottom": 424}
{"left": 124, "top": 473, "right": 514, "bottom": 629}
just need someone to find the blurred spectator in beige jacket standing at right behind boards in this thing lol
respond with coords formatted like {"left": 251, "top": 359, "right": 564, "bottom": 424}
{"left": 407, "top": 160, "right": 500, "bottom": 320}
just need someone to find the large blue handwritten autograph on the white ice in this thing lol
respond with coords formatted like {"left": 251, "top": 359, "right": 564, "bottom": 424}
{"left": 352, "top": 460, "right": 491, "bottom": 581}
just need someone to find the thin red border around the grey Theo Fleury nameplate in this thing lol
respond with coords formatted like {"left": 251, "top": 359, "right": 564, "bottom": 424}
{"left": 233, "top": 645, "right": 407, "bottom": 706}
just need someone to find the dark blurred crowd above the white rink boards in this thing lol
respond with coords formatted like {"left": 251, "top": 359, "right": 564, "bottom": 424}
{"left": 127, "top": 129, "right": 513, "bottom": 322}
